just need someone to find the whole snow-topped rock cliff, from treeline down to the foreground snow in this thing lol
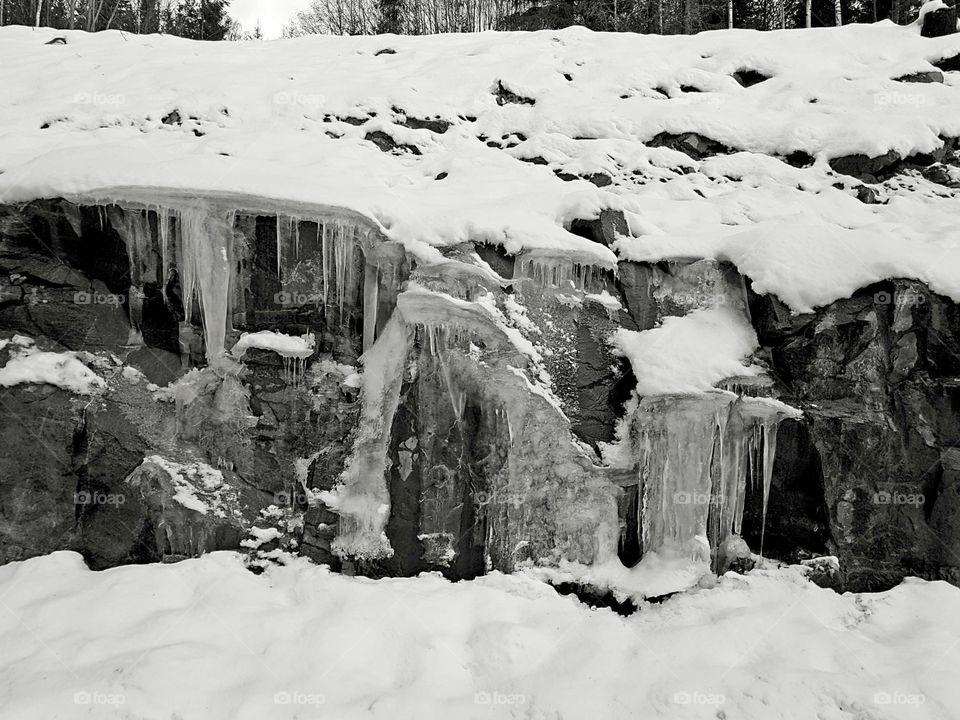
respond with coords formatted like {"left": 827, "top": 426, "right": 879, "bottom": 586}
{"left": 0, "top": 21, "right": 960, "bottom": 597}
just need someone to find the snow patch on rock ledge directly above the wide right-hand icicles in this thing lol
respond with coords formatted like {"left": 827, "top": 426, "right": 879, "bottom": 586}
{"left": 612, "top": 306, "right": 763, "bottom": 395}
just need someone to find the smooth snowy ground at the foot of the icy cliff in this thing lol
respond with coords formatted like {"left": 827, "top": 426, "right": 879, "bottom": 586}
{"left": 0, "top": 552, "right": 960, "bottom": 720}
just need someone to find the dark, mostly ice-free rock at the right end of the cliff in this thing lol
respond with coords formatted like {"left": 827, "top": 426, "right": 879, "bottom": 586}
{"left": 752, "top": 281, "right": 960, "bottom": 589}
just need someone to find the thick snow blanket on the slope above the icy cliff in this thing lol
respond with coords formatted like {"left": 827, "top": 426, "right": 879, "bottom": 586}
{"left": 0, "top": 22, "right": 960, "bottom": 311}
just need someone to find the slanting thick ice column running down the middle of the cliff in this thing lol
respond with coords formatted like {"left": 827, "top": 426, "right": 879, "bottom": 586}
{"left": 319, "top": 316, "right": 413, "bottom": 559}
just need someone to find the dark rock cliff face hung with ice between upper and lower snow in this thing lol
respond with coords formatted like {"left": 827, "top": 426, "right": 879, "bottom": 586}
{"left": 0, "top": 194, "right": 960, "bottom": 589}
